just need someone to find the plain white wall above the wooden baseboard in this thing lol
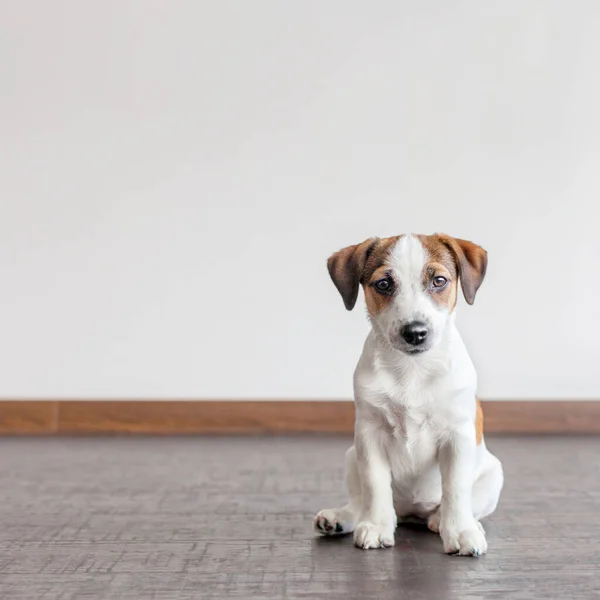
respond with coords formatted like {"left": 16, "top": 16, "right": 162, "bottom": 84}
{"left": 0, "top": 0, "right": 600, "bottom": 399}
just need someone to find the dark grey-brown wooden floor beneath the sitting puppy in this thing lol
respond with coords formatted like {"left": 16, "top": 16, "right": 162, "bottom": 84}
{"left": 0, "top": 437, "right": 600, "bottom": 600}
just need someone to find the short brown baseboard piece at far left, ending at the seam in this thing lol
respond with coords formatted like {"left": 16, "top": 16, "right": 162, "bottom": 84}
{"left": 0, "top": 400, "right": 58, "bottom": 435}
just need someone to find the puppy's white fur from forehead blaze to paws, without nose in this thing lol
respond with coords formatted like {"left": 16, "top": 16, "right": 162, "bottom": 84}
{"left": 315, "top": 236, "right": 503, "bottom": 556}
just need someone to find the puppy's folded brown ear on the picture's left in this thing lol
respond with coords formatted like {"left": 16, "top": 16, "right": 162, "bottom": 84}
{"left": 327, "top": 238, "right": 378, "bottom": 310}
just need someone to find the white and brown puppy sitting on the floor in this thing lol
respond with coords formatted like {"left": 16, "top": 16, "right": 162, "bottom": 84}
{"left": 315, "top": 234, "right": 504, "bottom": 556}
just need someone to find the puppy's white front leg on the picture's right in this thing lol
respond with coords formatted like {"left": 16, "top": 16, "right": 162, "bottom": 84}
{"left": 439, "top": 424, "right": 487, "bottom": 556}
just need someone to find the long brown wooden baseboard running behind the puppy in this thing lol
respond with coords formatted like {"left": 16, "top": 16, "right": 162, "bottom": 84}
{"left": 0, "top": 400, "right": 600, "bottom": 435}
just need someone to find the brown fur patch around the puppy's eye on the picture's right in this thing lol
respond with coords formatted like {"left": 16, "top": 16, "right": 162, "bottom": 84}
{"left": 418, "top": 235, "right": 458, "bottom": 312}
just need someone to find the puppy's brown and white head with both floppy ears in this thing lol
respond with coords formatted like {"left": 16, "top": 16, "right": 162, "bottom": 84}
{"left": 327, "top": 234, "right": 487, "bottom": 355}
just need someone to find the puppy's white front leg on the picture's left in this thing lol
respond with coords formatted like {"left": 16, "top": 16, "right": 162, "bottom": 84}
{"left": 354, "top": 426, "right": 396, "bottom": 550}
